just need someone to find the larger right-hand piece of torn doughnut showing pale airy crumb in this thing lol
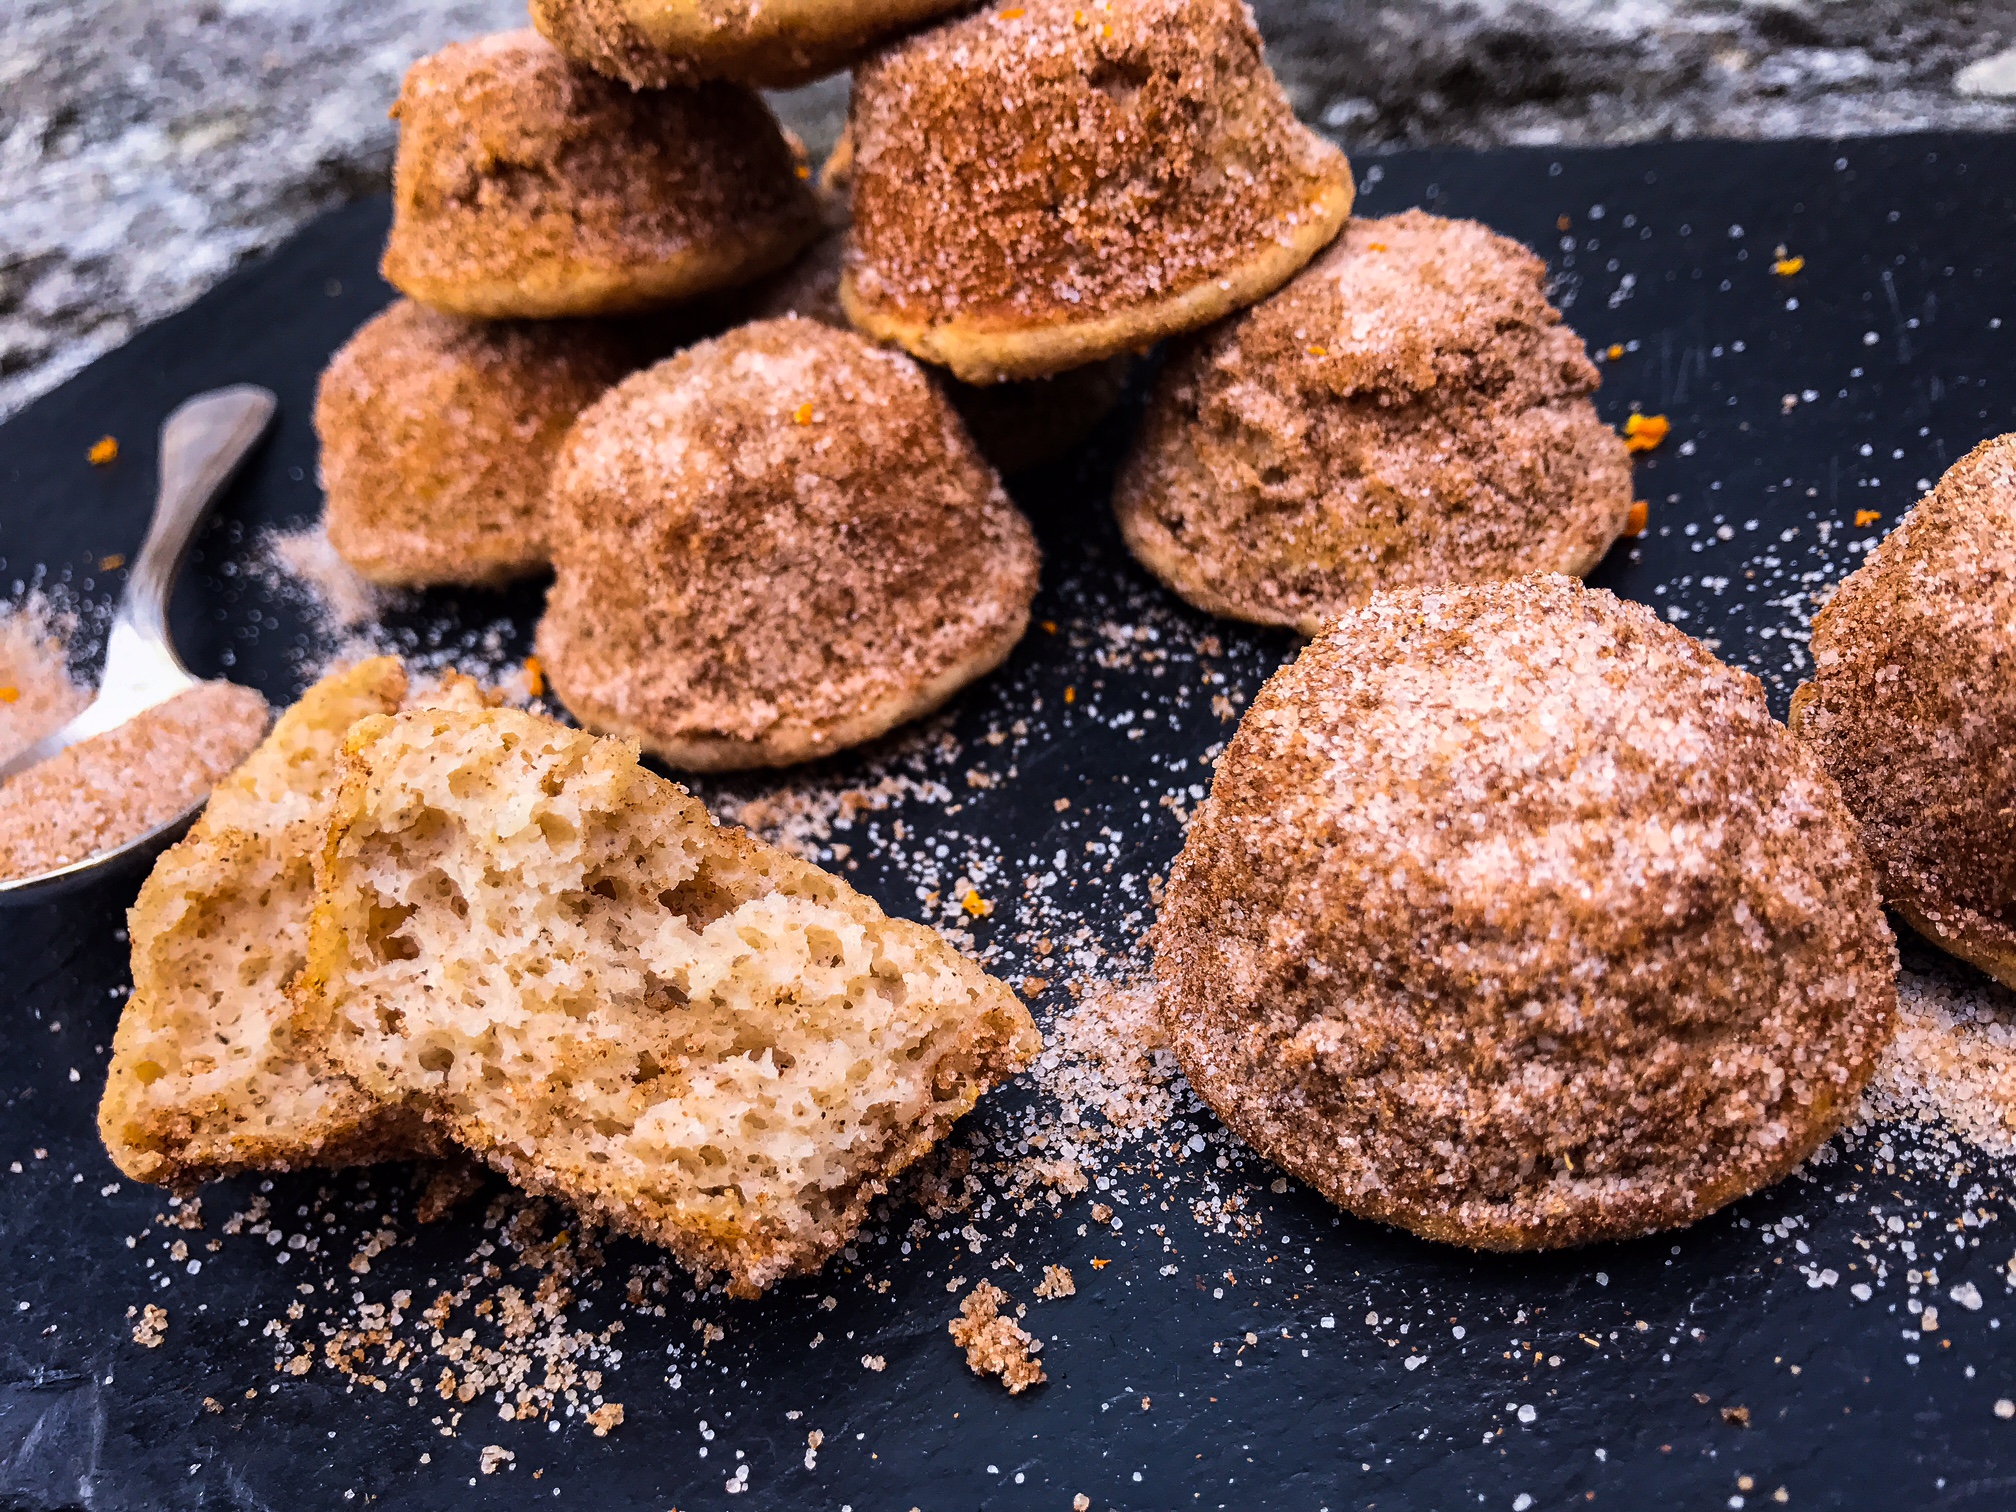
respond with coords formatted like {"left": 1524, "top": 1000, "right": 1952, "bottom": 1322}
{"left": 294, "top": 710, "right": 1042, "bottom": 1296}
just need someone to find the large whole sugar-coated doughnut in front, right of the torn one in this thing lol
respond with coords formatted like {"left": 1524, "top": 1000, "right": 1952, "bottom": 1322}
{"left": 1155, "top": 577, "right": 1897, "bottom": 1250}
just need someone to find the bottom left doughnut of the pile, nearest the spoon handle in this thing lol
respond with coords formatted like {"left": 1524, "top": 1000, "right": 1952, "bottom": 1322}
{"left": 314, "top": 300, "right": 635, "bottom": 587}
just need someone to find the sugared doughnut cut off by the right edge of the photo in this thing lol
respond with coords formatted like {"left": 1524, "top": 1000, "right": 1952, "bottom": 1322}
{"left": 1792, "top": 433, "right": 2016, "bottom": 986}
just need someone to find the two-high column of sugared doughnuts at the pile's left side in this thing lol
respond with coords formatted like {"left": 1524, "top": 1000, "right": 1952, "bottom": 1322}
{"left": 314, "top": 30, "right": 821, "bottom": 587}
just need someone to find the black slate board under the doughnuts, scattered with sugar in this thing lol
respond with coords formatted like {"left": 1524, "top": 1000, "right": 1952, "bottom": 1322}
{"left": 0, "top": 137, "right": 2016, "bottom": 1512}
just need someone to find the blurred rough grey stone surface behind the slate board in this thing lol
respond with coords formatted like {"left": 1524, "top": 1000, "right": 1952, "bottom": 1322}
{"left": 0, "top": 0, "right": 2016, "bottom": 427}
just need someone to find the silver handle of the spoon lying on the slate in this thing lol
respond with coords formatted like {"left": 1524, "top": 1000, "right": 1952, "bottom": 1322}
{"left": 105, "top": 383, "right": 278, "bottom": 657}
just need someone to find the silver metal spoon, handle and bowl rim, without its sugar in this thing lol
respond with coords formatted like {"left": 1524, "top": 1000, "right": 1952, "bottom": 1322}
{"left": 0, "top": 383, "right": 278, "bottom": 903}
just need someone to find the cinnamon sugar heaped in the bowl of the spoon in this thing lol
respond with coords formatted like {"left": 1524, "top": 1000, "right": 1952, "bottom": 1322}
{"left": 0, "top": 681, "right": 268, "bottom": 881}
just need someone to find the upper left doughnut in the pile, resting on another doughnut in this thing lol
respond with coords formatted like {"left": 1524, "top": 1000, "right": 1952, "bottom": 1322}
{"left": 383, "top": 30, "right": 818, "bottom": 319}
